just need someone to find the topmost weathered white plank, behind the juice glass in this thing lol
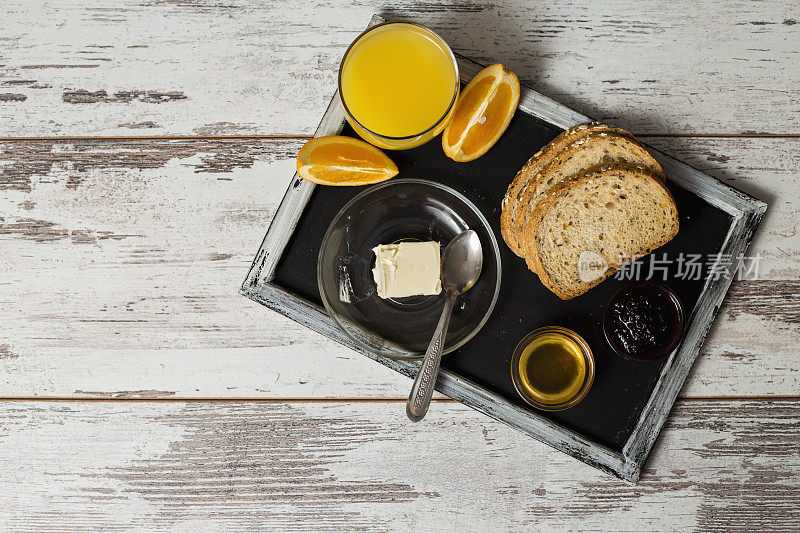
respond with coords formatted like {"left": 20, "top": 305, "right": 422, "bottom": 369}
{"left": 0, "top": 0, "right": 800, "bottom": 136}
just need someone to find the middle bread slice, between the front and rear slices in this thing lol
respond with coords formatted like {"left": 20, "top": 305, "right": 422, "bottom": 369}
{"left": 513, "top": 132, "right": 664, "bottom": 264}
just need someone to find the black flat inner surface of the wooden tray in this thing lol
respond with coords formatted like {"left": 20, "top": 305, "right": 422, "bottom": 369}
{"left": 274, "top": 112, "right": 732, "bottom": 451}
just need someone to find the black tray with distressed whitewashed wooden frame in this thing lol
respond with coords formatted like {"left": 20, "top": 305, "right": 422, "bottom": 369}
{"left": 241, "top": 16, "right": 767, "bottom": 481}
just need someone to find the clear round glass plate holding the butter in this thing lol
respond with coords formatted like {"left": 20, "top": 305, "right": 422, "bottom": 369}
{"left": 317, "top": 179, "right": 501, "bottom": 359}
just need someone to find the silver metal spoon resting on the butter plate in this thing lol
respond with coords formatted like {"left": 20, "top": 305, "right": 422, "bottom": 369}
{"left": 406, "top": 229, "right": 483, "bottom": 422}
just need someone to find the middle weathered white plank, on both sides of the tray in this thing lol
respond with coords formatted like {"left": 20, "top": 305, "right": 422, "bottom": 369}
{"left": 0, "top": 138, "right": 800, "bottom": 398}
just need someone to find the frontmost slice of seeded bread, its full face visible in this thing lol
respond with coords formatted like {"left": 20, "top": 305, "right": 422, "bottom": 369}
{"left": 524, "top": 165, "right": 679, "bottom": 300}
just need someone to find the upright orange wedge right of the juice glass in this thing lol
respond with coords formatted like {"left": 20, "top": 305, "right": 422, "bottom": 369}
{"left": 442, "top": 63, "right": 519, "bottom": 162}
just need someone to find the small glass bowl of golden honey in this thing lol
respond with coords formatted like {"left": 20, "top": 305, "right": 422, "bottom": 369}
{"left": 511, "top": 326, "right": 594, "bottom": 411}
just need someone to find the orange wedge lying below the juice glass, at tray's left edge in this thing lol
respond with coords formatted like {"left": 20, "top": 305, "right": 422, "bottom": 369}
{"left": 297, "top": 135, "right": 397, "bottom": 185}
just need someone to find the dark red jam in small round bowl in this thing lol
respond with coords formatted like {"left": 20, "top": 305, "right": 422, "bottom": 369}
{"left": 603, "top": 282, "right": 683, "bottom": 359}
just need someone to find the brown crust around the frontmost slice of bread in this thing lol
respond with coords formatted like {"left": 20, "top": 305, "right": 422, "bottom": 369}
{"left": 525, "top": 164, "right": 680, "bottom": 300}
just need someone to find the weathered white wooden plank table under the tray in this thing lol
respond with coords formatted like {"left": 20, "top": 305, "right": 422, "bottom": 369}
{"left": 0, "top": 0, "right": 800, "bottom": 531}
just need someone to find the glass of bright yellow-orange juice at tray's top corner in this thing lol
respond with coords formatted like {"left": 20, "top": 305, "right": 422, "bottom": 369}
{"left": 339, "top": 21, "right": 460, "bottom": 150}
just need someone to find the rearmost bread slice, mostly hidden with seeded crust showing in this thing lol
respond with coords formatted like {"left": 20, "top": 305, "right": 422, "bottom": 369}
{"left": 500, "top": 122, "right": 629, "bottom": 257}
